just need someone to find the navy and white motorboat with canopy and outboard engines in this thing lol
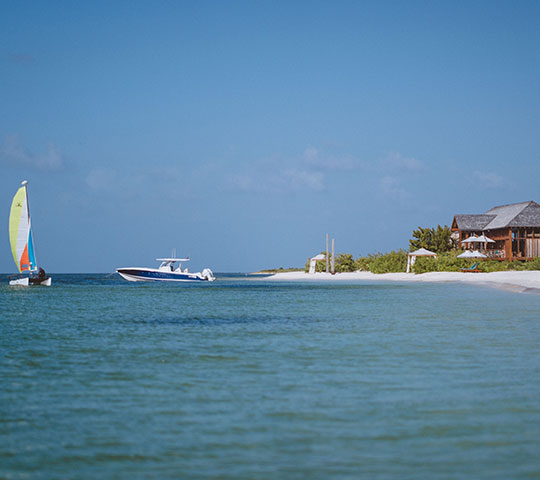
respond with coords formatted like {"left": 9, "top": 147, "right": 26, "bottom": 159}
{"left": 116, "top": 258, "right": 215, "bottom": 282}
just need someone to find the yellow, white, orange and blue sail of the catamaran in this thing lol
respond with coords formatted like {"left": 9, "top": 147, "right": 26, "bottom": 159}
{"left": 9, "top": 182, "right": 37, "bottom": 272}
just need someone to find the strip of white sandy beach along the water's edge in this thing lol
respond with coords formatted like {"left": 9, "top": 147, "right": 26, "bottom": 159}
{"left": 266, "top": 271, "right": 540, "bottom": 293}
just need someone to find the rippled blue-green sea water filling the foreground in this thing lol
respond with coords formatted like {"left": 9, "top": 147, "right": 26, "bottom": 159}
{"left": 0, "top": 274, "right": 540, "bottom": 480}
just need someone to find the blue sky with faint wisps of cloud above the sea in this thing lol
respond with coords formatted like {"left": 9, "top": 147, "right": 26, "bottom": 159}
{"left": 0, "top": 0, "right": 540, "bottom": 272}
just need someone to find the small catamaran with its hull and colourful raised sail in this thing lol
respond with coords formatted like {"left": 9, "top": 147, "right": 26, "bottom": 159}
{"left": 9, "top": 180, "right": 51, "bottom": 287}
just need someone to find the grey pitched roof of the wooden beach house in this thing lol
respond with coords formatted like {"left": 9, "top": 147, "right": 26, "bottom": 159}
{"left": 454, "top": 201, "right": 540, "bottom": 232}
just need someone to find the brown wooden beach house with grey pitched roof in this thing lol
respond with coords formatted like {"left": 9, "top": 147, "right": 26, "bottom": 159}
{"left": 452, "top": 201, "right": 540, "bottom": 260}
